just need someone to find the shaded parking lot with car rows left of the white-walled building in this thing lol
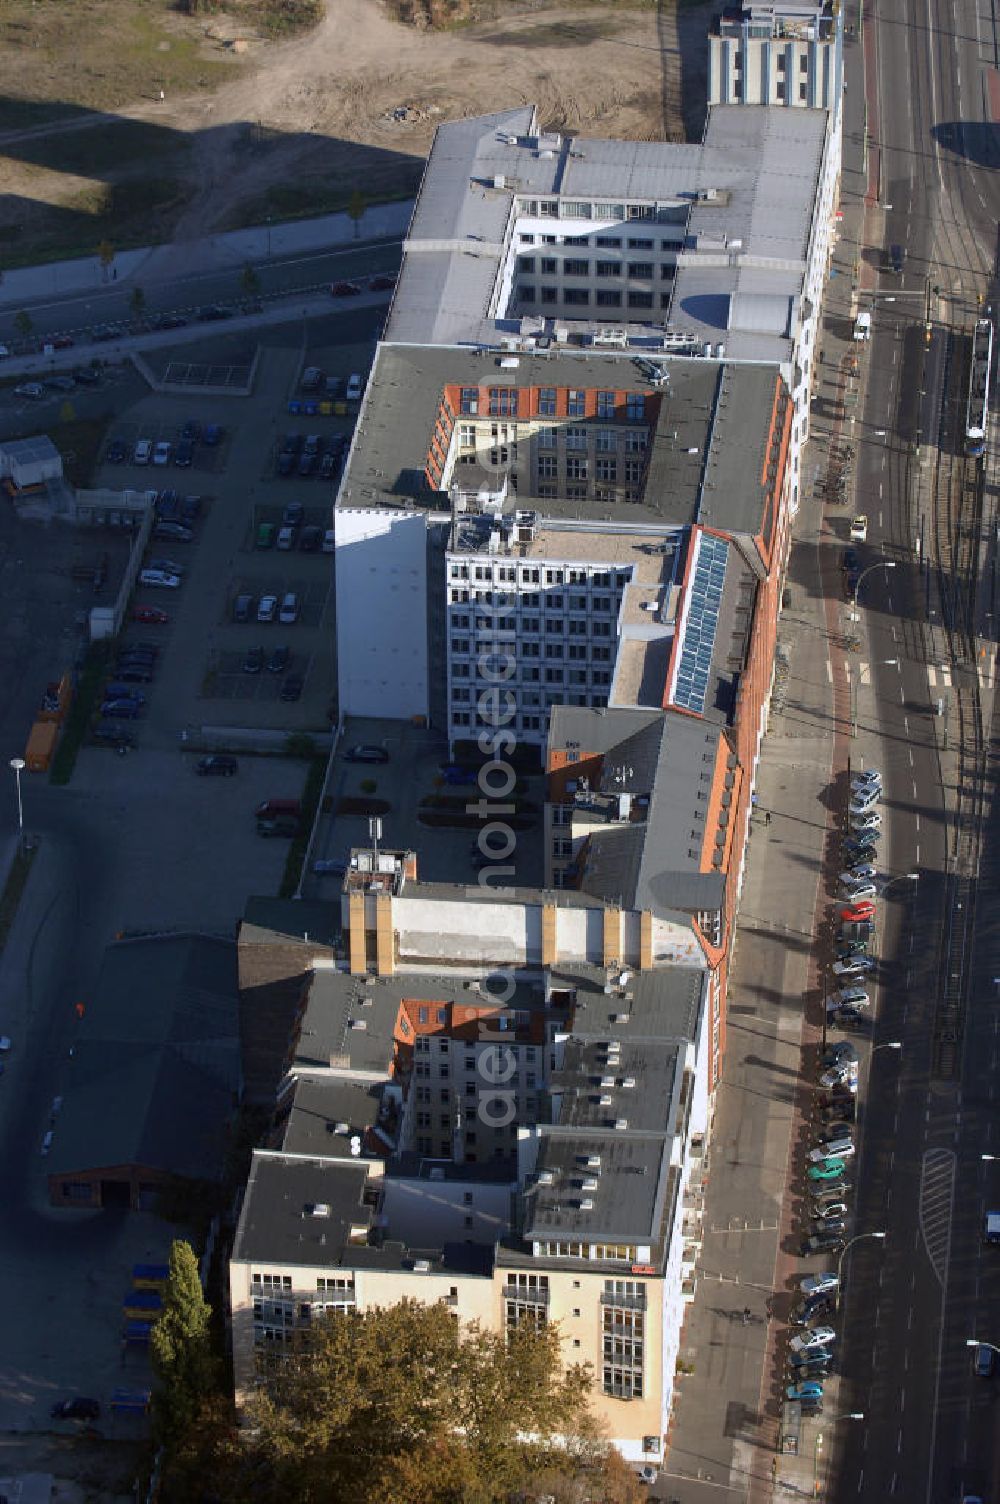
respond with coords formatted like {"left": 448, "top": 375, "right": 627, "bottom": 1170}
{"left": 83, "top": 310, "right": 377, "bottom": 749}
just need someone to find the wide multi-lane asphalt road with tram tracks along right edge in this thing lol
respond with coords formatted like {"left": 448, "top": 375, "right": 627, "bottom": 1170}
{"left": 835, "top": 0, "right": 1000, "bottom": 1504}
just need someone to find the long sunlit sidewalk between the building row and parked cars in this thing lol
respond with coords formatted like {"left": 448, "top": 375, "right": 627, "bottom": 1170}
{"left": 660, "top": 11, "right": 880, "bottom": 1504}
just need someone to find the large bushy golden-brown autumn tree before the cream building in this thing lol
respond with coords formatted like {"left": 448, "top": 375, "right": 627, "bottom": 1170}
{"left": 237, "top": 1301, "right": 628, "bottom": 1504}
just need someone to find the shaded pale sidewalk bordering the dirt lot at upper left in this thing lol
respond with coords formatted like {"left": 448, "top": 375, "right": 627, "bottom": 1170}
{"left": 0, "top": 199, "right": 414, "bottom": 308}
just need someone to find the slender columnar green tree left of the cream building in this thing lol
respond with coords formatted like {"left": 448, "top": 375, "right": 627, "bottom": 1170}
{"left": 149, "top": 1239, "right": 218, "bottom": 1445}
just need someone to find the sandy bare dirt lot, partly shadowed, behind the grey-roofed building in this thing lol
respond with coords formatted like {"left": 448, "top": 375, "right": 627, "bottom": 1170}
{"left": 0, "top": 0, "right": 714, "bottom": 258}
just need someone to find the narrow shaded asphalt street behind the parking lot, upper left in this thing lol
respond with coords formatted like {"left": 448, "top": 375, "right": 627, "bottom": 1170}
{"left": 0, "top": 241, "right": 400, "bottom": 349}
